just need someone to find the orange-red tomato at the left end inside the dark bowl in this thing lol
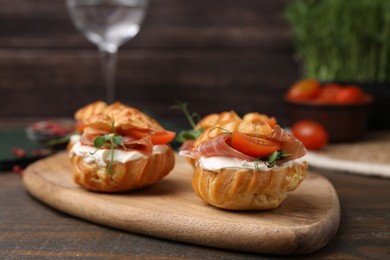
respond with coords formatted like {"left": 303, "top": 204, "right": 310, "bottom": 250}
{"left": 286, "top": 79, "right": 321, "bottom": 101}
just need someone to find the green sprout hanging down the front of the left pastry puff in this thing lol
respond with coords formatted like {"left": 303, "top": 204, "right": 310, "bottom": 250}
{"left": 91, "top": 122, "right": 124, "bottom": 174}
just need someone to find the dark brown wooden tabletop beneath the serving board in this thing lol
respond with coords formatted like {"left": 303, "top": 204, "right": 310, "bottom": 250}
{"left": 0, "top": 121, "right": 390, "bottom": 259}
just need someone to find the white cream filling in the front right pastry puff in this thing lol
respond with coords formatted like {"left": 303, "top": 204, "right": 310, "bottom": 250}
{"left": 198, "top": 156, "right": 306, "bottom": 171}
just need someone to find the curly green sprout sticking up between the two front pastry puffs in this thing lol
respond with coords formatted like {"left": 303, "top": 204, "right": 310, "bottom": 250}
{"left": 172, "top": 100, "right": 204, "bottom": 143}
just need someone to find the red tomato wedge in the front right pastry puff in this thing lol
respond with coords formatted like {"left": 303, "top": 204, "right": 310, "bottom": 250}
{"left": 231, "top": 131, "right": 282, "bottom": 157}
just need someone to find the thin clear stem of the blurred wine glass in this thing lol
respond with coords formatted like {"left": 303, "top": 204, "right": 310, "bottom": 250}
{"left": 99, "top": 48, "right": 117, "bottom": 104}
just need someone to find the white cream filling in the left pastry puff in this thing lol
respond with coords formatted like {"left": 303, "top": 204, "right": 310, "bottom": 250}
{"left": 69, "top": 141, "right": 168, "bottom": 167}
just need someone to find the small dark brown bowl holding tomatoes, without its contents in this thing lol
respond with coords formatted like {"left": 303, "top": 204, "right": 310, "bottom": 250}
{"left": 285, "top": 98, "right": 372, "bottom": 142}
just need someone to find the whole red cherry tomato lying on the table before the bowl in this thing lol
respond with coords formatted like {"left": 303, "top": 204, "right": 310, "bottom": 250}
{"left": 291, "top": 120, "right": 329, "bottom": 150}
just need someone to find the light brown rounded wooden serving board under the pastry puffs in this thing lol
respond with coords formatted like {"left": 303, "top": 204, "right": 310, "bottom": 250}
{"left": 23, "top": 153, "right": 340, "bottom": 254}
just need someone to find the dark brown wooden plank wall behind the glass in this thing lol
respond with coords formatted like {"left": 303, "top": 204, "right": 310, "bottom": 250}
{"left": 0, "top": 0, "right": 299, "bottom": 127}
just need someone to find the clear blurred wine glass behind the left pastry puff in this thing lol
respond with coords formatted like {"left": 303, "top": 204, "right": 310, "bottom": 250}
{"left": 66, "top": 0, "right": 148, "bottom": 104}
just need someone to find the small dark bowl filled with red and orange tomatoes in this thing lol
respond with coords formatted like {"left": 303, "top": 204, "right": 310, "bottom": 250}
{"left": 285, "top": 79, "right": 373, "bottom": 142}
